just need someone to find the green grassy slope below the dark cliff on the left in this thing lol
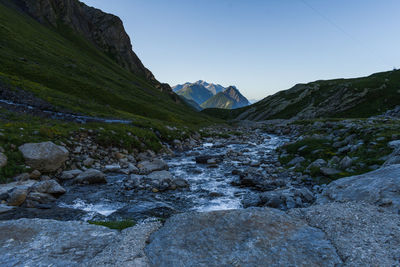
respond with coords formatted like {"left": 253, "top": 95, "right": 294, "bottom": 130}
{"left": 0, "top": 0, "right": 209, "bottom": 124}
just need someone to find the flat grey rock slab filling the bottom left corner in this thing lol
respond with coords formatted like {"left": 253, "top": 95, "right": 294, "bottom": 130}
{"left": 0, "top": 219, "right": 119, "bottom": 266}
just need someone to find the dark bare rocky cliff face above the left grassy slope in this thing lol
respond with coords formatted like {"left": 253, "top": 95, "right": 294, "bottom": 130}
{"left": 18, "top": 0, "right": 159, "bottom": 87}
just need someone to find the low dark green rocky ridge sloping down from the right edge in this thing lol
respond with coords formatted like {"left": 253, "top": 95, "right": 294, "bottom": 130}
{"left": 205, "top": 70, "right": 400, "bottom": 121}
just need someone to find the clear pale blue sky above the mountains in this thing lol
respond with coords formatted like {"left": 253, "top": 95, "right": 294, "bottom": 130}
{"left": 81, "top": 0, "right": 400, "bottom": 99}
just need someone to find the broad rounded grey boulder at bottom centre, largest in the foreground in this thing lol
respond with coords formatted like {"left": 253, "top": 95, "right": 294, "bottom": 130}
{"left": 145, "top": 208, "right": 342, "bottom": 267}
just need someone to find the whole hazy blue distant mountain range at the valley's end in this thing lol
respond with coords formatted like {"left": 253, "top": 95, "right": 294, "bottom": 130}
{"left": 172, "top": 80, "right": 250, "bottom": 109}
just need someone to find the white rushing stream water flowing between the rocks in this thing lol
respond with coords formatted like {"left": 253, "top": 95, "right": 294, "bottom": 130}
{"left": 58, "top": 133, "right": 285, "bottom": 220}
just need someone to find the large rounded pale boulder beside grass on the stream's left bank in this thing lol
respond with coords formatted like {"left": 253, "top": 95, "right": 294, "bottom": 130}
{"left": 19, "top": 142, "right": 68, "bottom": 172}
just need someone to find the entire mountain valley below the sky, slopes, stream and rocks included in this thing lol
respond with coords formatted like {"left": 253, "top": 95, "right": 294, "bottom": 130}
{"left": 0, "top": 0, "right": 400, "bottom": 266}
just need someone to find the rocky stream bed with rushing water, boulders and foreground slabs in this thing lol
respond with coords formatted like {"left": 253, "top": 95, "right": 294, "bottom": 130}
{"left": 0, "top": 118, "right": 400, "bottom": 266}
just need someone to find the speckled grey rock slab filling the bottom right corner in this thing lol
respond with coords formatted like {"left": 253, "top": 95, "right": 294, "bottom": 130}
{"left": 289, "top": 202, "right": 400, "bottom": 266}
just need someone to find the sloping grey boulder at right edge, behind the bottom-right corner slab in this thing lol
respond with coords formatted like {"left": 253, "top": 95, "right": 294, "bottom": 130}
{"left": 317, "top": 164, "right": 400, "bottom": 211}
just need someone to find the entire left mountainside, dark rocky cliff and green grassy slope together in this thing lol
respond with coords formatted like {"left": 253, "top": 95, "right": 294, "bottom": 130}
{"left": 0, "top": 0, "right": 208, "bottom": 123}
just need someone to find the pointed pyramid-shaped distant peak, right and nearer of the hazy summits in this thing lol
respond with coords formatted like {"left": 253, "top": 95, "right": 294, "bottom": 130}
{"left": 201, "top": 86, "right": 250, "bottom": 109}
